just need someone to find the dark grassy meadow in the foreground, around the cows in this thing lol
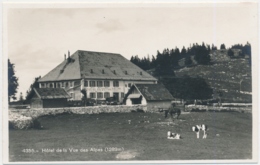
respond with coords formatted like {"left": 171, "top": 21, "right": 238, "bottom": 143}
{"left": 9, "top": 112, "right": 252, "bottom": 161}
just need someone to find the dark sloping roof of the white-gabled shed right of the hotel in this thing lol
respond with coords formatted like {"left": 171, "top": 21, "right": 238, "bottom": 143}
{"left": 134, "top": 84, "right": 174, "bottom": 101}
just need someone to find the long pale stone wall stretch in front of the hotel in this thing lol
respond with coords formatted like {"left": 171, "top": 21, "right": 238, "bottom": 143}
{"left": 18, "top": 105, "right": 147, "bottom": 118}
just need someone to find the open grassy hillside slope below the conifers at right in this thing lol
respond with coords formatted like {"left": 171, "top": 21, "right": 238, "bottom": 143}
{"left": 175, "top": 50, "right": 252, "bottom": 102}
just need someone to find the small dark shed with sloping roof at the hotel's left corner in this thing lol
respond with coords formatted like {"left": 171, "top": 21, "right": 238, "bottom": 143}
{"left": 30, "top": 88, "right": 70, "bottom": 108}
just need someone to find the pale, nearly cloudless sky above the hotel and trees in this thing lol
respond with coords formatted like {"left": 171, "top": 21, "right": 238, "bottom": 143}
{"left": 4, "top": 3, "right": 258, "bottom": 98}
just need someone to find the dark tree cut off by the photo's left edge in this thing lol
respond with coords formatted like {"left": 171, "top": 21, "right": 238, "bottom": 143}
{"left": 8, "top": 59, "right": 19, "bottom": 102}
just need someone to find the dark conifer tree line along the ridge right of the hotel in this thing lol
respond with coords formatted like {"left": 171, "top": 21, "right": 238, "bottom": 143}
{"left": 130, "top": 42, "right": 251, "bottom": 70}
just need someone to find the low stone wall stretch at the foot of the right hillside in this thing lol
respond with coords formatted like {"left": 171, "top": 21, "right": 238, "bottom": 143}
{"left": 185, "top": 105, "right": 252, "bottom": 113}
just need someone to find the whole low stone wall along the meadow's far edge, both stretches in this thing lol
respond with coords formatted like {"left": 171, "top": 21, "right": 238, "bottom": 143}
{"left": 11, "top": 105, "right": 252, "bottom": 118}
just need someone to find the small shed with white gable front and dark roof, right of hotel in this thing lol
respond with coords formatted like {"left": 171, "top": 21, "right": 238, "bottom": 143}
{"left": 124, "top": 84, "right": 174, "bottom": 110}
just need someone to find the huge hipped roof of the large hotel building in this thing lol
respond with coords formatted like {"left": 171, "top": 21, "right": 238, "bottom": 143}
{"left": 39, "top": 50, "right": 157, "bottom": 82}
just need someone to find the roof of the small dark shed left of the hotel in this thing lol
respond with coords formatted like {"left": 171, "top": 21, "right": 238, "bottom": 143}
{"left": 33, "top": 88, "right": 70, "bottom": 99}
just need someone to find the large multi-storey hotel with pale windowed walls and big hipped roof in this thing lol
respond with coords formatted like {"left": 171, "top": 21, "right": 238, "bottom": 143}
{"left": 39, "top": 50, "right": 157, "bottom": 102}
